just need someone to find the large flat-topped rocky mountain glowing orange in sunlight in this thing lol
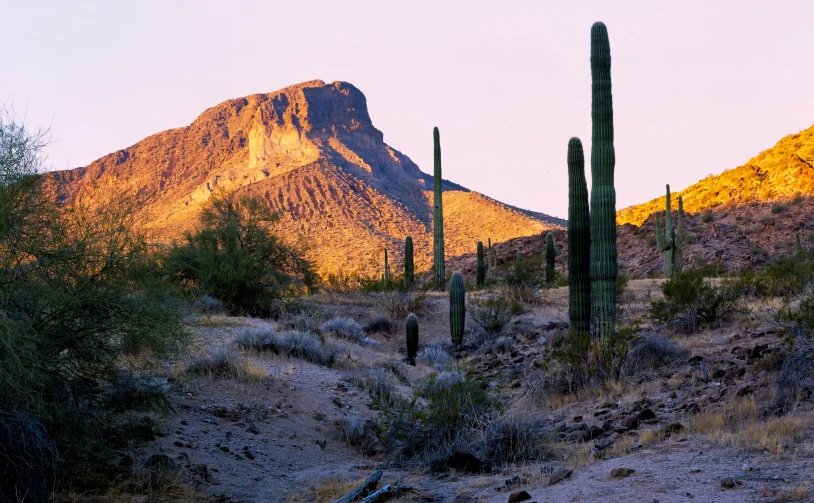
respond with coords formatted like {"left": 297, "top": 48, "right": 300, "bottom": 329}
{"left": 50, "top": 80, "right": 564, "bottom": 275}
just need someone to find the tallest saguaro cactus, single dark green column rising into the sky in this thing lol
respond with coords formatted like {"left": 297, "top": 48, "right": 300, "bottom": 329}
{"left": 591, "top": 23, "right": 617, "bottom": 341}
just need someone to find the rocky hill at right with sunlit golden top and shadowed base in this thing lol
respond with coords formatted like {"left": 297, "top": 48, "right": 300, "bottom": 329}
{"left": 450, "top": 126, "right": 814, "bottom": 277}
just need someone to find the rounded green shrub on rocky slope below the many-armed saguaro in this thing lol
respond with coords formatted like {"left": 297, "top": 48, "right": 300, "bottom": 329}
{"left": 649, "top": 271, "right": 746, "bottom": 333}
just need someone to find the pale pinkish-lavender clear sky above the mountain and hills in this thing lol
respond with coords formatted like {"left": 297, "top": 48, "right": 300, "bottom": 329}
{"left": 0, "top": 0, "right": 814, "bottom": 217}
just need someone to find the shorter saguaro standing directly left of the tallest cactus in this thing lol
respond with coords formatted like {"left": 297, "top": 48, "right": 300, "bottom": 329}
{"left": 568, "top": 138, "right": 591, "bottom": 334}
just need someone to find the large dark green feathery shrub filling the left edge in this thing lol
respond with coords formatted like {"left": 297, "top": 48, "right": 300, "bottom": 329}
{"left": 0, "top": 110, "right": 187, "bottom": 501}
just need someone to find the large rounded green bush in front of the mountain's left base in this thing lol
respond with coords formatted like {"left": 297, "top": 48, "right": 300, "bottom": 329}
{"left": 165, "top": 192, "right": 318, "bottom": 316}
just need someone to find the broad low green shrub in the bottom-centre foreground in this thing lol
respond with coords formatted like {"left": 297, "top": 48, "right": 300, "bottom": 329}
{"left": 374, "top": 372, "right": 500, "bottom": 456}
